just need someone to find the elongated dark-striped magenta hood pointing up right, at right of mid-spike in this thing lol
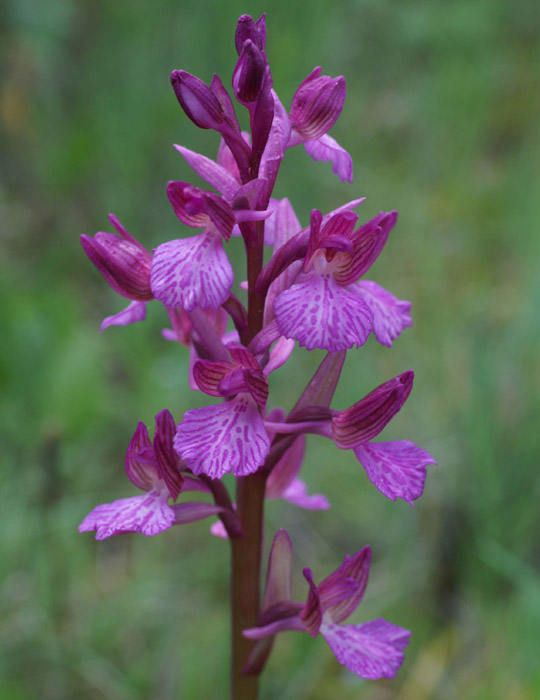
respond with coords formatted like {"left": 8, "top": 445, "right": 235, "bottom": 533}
{"left": 332, "top": 370, "right": 414, "bottom": 450}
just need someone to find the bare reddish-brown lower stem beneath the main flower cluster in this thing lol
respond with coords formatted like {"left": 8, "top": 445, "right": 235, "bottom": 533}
{"left": 231, "top": 474, "right": 266, "bottom": 700}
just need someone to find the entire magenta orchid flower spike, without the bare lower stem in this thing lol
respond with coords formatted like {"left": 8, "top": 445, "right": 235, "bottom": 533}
{"left": 79, "top": 15, "right": 435, "bottom": 678}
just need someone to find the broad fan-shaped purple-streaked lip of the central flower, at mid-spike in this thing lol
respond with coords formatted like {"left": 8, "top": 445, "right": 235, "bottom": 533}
{"left": 174, "top": 394, "right": 270, "bottom": 479}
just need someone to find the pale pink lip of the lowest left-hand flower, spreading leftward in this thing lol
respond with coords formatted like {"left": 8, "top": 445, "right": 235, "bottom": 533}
{"left": 79, "top": 490, "right": 175, "bottom": 540}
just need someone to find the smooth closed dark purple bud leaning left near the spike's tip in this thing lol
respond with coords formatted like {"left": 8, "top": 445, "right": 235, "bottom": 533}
{"left": 171, "top": 70, "right": 224, "bottom": 130}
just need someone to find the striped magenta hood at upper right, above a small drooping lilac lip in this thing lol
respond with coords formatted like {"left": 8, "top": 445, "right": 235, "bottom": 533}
{"left": 290, "top": 67, "right": 346, "bottom": 139}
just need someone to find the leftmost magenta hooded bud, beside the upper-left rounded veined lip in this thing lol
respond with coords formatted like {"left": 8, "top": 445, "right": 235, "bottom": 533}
{"left": 81, "top": 215, "right": 154, "bottom": 301}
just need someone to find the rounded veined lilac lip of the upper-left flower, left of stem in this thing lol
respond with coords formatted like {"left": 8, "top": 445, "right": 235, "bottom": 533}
{"left": 150, "top": 231, "right": 234, "bottom": 311}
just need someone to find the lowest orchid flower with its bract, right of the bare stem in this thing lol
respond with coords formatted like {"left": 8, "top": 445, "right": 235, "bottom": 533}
{"left": 243, "top": 533, "right": 410, "bottom": 680}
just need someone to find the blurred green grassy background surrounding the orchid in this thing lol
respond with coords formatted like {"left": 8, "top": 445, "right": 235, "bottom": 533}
{"left": 0, "top": 0, "right": 540, "bottom": 700}
